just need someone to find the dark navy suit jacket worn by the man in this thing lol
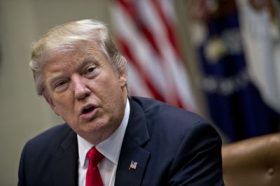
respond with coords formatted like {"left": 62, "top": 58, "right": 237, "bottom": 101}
{"left": 18, "top": 97, "right": 223, "bottom": 186}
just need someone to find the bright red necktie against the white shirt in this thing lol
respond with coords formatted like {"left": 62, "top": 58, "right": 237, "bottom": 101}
{"left": 86, "top": 147, "right": 104, "bottom": 186}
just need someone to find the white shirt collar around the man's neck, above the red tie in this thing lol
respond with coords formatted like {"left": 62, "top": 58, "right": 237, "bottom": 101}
{"left": 77, "top": 99, "right": 130, "bottom": 166}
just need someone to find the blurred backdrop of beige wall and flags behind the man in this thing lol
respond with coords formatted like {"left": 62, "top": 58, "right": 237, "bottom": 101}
{"left": 0, "top": 0, "right": 280, "bottom": 186}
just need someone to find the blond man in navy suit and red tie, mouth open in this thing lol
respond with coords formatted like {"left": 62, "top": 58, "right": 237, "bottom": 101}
{"left": 18, "top": 20, "right": 223, "bottom": 186}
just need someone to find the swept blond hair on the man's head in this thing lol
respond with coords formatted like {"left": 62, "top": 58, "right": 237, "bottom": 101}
{"left": 29, "top": 19, "right": 127, "bottom": 95}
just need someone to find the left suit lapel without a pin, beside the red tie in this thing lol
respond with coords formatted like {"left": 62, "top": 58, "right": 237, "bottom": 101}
{"left": 52, "top": 129, "right": 78, "bottom": 186}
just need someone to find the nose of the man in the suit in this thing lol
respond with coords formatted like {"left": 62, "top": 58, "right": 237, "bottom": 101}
{"left": 72, "top": 76, "right": 90, "bottom": 100}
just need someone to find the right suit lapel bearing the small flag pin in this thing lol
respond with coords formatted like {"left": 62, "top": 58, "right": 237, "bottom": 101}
{"left": 115, "top": 99, "right": 150, "bottom": 186}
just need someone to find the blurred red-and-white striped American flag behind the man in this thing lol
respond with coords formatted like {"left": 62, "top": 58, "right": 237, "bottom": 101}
{"left": 112, "top": 0, "right": 196, "bottom": 110}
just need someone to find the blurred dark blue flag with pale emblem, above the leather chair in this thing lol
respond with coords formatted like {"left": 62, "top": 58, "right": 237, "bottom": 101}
{"left": 197, "top": 2, "right": 279, "bottom": 141}
